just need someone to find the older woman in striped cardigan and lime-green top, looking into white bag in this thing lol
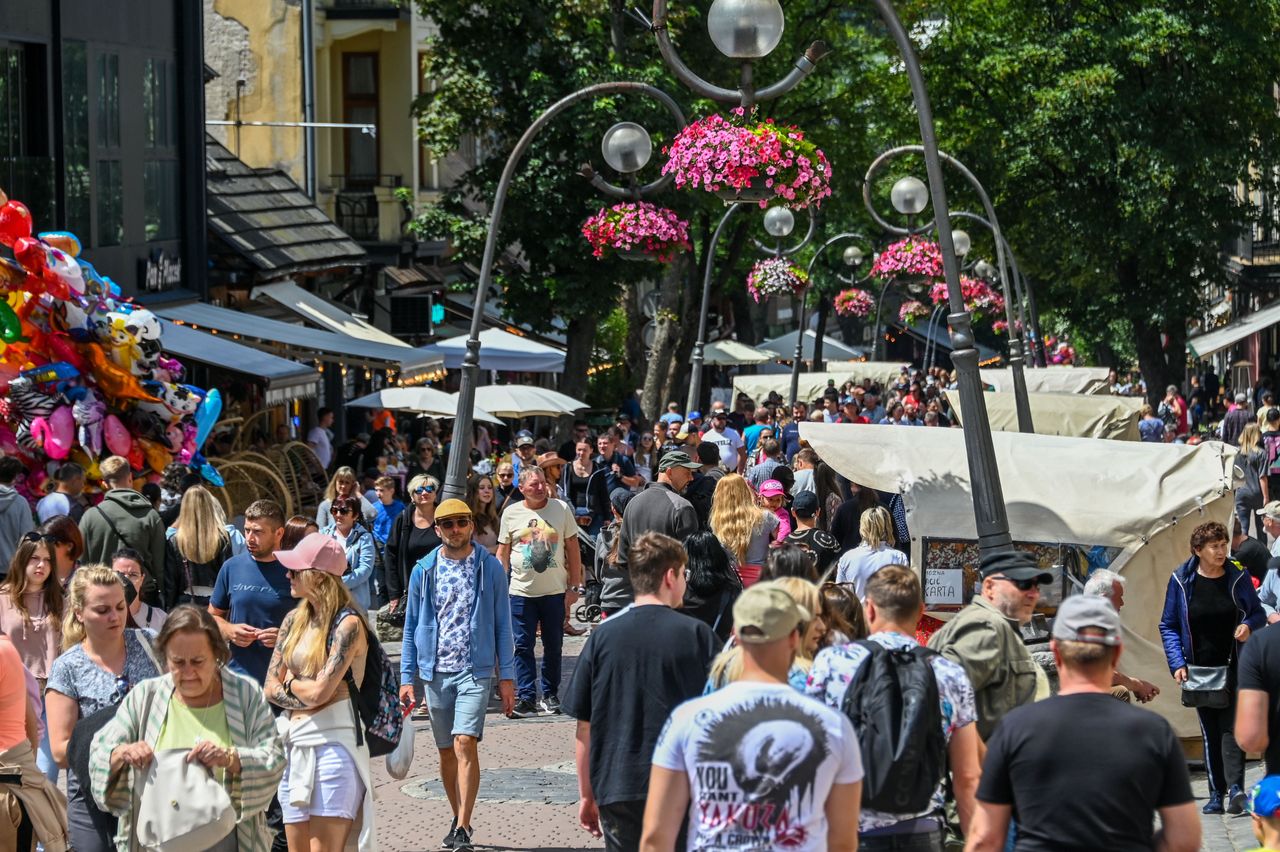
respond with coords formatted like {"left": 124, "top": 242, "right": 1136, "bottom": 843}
{"left": 90, "top": 604, "right": 284, "bottom": 852}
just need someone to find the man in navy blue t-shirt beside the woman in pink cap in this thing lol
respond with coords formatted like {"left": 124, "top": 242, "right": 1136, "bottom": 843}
{"left": 209, "top": 500, "right": 297, "bottom": 683}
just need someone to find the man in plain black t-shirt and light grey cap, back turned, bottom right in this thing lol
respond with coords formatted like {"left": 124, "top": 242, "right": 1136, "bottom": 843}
{"left": 965, "top": 595, "right": 1201, "bottom": 852}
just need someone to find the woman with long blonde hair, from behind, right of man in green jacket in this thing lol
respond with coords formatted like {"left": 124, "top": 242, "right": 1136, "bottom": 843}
{"left": 161, "top": 485, "right": 234, "bottom": 610}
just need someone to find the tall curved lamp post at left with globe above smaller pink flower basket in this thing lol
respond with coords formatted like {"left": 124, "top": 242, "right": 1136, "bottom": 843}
{"left": 443, "top": 82, "right": 685, "bottom": 499}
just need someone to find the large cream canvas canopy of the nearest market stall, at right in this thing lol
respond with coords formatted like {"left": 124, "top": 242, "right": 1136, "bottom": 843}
{"left": 800, "top": 422, "right": 1235, "bottom": 737}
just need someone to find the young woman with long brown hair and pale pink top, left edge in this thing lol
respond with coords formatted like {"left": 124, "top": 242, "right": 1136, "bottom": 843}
{"left": 0, "top": 531, "right": 63, "bottom": 784}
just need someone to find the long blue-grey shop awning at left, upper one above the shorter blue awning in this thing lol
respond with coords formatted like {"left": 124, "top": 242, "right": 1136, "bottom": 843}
{"left": 155, "top": 302, "right": 444, "bottom": 379}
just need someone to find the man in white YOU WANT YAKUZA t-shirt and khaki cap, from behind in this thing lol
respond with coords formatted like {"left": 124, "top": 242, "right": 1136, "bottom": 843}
{"left": 640, "top": 582, "right": 863, "bottom": 852}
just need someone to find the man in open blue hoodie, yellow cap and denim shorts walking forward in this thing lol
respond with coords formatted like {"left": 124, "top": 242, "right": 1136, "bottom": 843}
{"left": 399, "top": 499, "right": 516, "bottom": 852}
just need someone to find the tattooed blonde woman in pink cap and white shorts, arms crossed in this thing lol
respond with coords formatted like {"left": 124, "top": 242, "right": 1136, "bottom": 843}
{"left": 264, "top": 533, "right": 378, "bottom": 852}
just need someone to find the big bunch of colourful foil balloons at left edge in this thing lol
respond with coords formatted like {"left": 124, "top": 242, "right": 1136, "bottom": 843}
{"left": 0, "top": 192, "right": 223, "bottom": 486}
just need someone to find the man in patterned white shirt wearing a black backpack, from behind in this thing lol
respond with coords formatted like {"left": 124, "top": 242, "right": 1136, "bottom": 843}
{"left": 805, "top": 565, "right": 979, "bottom": 852}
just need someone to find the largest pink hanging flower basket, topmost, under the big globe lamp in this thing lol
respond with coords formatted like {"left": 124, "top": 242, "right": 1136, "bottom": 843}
{"left": 662, "top": 107, "right": 831, "bottom": 210}
